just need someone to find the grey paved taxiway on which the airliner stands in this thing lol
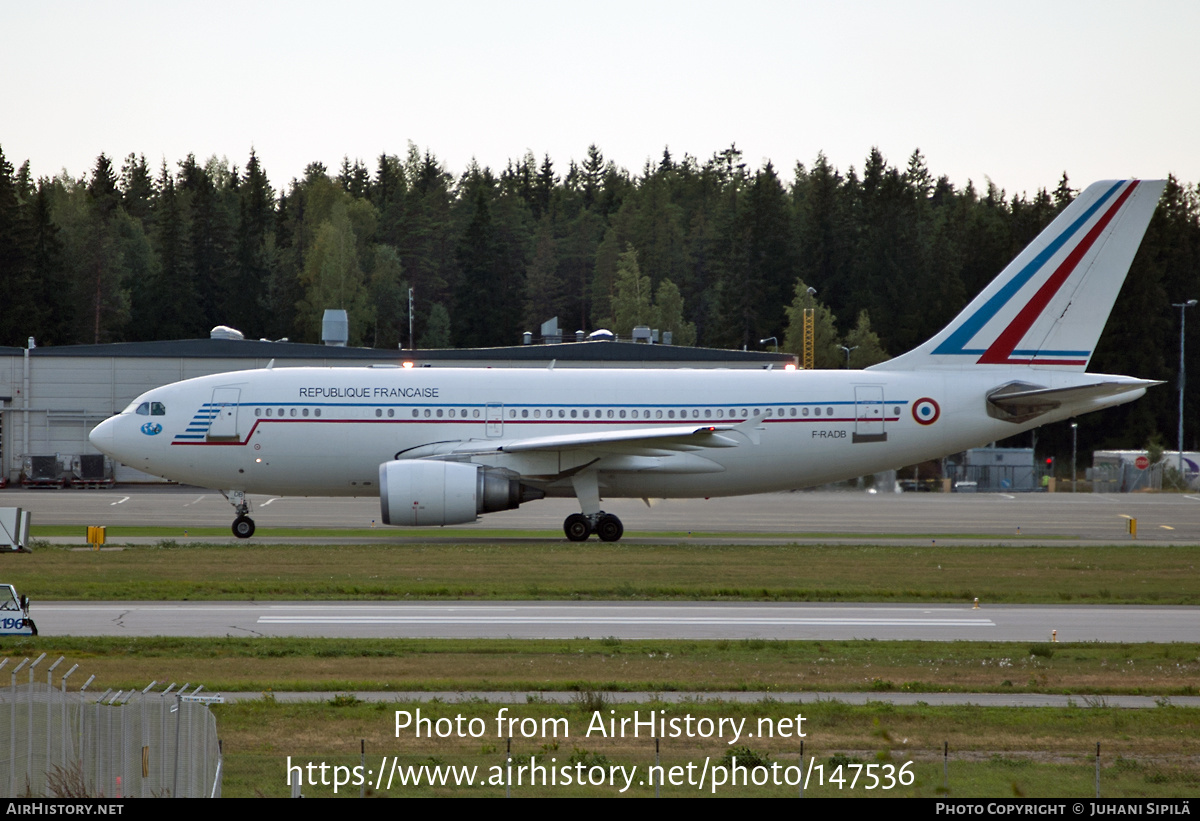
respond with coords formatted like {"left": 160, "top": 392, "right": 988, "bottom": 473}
{"left": 9, "top": 487, "right": 1200, "bottom": 545}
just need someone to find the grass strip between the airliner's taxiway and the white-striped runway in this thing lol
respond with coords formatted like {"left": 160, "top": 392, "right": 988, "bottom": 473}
{"left": 0, "top": 539, "right": 1200, "bottom": 602}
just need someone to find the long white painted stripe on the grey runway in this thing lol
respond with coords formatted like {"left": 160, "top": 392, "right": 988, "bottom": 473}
{"left": 258, "top": 616, "right": 996, "bottom": 628}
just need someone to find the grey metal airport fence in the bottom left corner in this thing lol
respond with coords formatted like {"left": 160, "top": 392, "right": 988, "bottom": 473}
{"left": 0, "top": 672, "right": 222, "bottom": 798}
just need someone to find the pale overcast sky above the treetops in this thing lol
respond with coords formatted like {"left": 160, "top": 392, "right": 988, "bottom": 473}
{"left": 0, "top": 0, "right": 1200, "bottom": 193}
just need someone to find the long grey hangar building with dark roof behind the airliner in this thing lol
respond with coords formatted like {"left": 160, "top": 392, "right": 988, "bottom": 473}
{"left": 0, "top": 338, "right": 796, "bottom": 486}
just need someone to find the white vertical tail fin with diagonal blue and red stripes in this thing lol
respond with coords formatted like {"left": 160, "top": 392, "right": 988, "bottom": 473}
{"left": 875, "top": 180, "right": 1165, "bottom": 371}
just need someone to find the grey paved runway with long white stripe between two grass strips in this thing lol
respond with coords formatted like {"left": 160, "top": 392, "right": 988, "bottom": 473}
{"left": 34, "top": 601, "right": 1200, "bottom": 642}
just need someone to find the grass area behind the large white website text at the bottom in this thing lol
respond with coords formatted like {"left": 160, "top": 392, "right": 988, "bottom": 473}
{"left": 214, "top": 694, "right": 1200, "bottom": 798}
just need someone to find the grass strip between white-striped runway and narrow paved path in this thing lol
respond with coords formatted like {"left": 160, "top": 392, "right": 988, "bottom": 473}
{"left": 5, "top": 636, "right": 1200, "bottom": 697}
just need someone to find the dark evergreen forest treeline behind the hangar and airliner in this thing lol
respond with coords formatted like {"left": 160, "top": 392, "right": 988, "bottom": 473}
{"left": 0, "top": 145, "right": 1200, "bottom": 458}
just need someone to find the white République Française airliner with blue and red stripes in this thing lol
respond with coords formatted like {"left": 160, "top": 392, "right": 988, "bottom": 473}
{"left": 90, "top": 180, "right": 1163, "bottom": 541}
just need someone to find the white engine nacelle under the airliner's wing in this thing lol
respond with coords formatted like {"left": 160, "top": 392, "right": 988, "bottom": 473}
{"left": 379, "top": 459, "right": 545, "bottom": 527}
